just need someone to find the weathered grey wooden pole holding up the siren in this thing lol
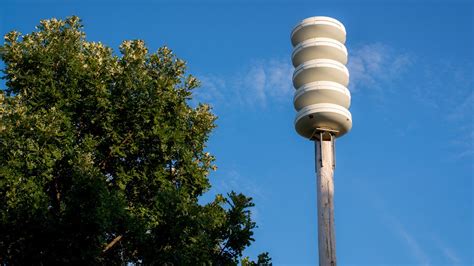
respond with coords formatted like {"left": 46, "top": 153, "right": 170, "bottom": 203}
{"left": 314, "top": 137, "right": 336, "bottom": 266}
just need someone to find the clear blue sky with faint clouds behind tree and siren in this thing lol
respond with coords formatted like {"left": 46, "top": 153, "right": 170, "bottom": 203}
{"left": 0, "top": 0, "right": 474, "bottom": 265}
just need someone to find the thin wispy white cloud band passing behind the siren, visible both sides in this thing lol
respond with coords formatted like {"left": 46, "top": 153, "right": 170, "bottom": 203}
{"left": 195, "top": 43, "right": 413, "bottom": 107}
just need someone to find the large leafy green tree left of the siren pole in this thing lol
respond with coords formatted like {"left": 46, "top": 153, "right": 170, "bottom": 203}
{"left": 0, "top": 17, "right": 270, "bottom": 265}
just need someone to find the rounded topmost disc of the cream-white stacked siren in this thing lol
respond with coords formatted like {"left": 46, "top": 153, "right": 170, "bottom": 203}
{"left": 291, "top": 16, "right": 346, "bottom": 46}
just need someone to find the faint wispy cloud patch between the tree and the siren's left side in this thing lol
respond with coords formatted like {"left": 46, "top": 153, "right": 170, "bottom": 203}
{"left": 195, "top": 58, "right": 294, "bottom": 108}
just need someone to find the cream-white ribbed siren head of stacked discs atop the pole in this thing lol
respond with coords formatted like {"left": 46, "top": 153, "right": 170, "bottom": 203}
{"left": 291, "top": 17, "right": 352, "bottom": 138}
